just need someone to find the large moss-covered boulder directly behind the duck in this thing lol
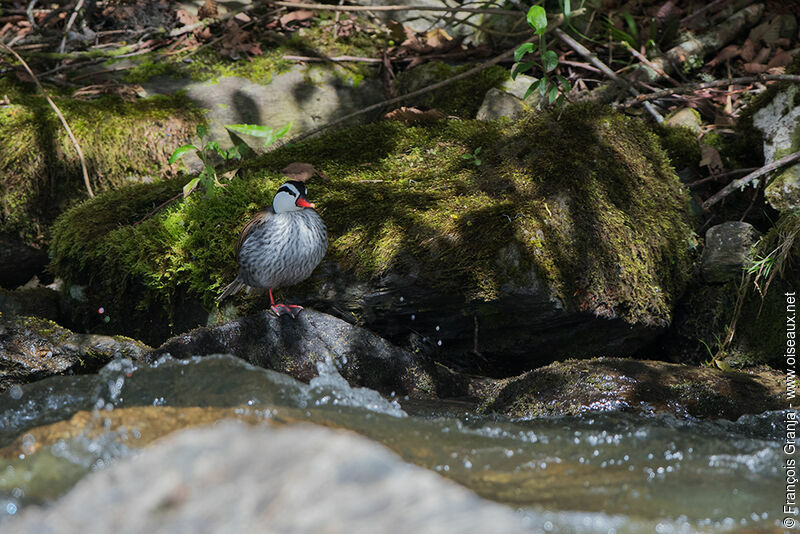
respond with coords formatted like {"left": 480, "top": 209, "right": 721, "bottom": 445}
{"left": 51, "top": 104, "right": 691, "bottom": 369}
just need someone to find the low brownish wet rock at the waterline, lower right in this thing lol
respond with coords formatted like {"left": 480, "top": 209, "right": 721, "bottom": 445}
{"left": 481, "top": 358, "right": 788, "bottom": 419}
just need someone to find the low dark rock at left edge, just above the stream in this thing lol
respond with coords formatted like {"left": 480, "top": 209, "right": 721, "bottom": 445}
{"left": 0, "top": 313, "right": 150, "bottom": 391}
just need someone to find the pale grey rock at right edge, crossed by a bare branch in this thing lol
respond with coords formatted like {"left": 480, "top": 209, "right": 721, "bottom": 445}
{"left": 753, "top": 85, "right": 800, "bottom": 211}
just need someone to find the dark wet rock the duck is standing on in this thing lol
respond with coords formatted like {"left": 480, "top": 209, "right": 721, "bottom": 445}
{"left": 147, "top": 309, "right": 436, "bottom": 396}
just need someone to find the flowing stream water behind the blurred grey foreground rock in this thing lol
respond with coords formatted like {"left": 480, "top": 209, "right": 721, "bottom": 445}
{"left": 0, "top": 355, "right": 785, "bottom": 532}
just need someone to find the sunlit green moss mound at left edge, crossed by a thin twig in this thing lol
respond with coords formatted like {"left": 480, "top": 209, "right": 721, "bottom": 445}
{"left": 0, "top": 78, "right": 201, "bottom": 242}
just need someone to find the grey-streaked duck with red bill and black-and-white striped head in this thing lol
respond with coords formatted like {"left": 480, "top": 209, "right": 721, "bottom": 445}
{"left": 217, "top": 180, "right": 328, "bottom": 319}
